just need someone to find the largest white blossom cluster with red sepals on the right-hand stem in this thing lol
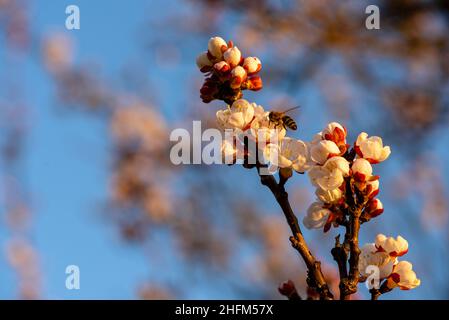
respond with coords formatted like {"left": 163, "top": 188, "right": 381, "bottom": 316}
{"left": 303, "top": 122, "right": 391, "bottom": 231}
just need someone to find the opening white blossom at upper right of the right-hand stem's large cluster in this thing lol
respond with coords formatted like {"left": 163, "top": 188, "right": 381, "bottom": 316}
{"left": 355, "top": 132, "right": 391, "bottom": 164}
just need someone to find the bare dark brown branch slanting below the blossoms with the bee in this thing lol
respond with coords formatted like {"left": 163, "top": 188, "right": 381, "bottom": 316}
{"left": 259, "top": 174, "right": 333, "bottom": 300}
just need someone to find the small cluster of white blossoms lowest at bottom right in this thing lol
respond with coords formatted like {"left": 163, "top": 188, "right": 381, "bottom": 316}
{"left": 359, "top": 234, "right": 421, "bottom": 290}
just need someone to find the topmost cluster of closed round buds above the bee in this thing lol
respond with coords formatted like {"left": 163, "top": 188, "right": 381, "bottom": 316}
{"left": 196, "top": 37, "right": 262, "bottom": 103}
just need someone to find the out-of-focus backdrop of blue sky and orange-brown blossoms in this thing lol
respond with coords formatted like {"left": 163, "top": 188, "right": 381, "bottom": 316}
{"left": 0, "top": 0, "right": 449, "bottom": 299}
